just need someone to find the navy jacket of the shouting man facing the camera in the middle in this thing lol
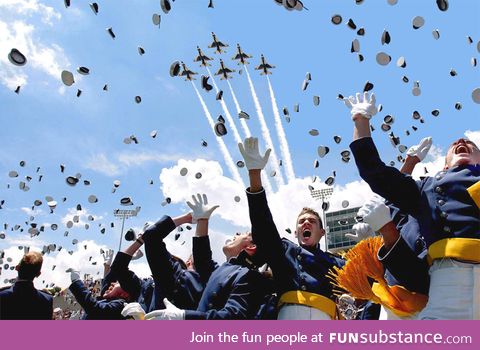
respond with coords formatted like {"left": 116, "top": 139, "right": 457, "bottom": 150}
{"left": 247, "top": 190, "right": 345, "bottom": 301}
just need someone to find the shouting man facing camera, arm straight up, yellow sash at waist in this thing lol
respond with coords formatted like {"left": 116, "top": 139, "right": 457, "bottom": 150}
{"left": 239, "top": 138, "right": 344, "bottom": 320}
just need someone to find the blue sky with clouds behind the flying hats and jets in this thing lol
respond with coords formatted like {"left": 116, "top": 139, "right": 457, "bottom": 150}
{"left": 0, "top": 0, "right": 480, "bottom": 284}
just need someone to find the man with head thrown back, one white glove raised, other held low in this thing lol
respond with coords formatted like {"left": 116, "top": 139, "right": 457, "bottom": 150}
{"left": 145, "top": 194, "right": 266, "bottom": 320}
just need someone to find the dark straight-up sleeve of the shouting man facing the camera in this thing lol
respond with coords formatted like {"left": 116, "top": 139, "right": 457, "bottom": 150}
{"left": 247, "top": 189, "right": 291, "bottom": 280}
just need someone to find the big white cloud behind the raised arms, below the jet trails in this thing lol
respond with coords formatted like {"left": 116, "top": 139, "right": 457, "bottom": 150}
{"left": 160, "top": 159, "right": 372, "bottom": 239}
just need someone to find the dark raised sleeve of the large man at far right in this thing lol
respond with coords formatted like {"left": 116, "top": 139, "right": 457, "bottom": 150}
{"left": 350, "top": 137, "right": 421, "bottom": 217}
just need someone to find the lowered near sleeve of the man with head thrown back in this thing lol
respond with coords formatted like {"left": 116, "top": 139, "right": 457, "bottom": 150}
{"left": 185, "top": 271, "right": 263, "bottom": 320}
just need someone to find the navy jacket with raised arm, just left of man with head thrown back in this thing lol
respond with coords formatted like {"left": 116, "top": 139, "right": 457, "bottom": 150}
{"left": 143, "top": 216, "right": 205, "bottom": 311}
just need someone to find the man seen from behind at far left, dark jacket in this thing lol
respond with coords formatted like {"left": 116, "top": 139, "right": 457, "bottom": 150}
{"left": 0, "top": 252, "right": 53, "bottom": 320}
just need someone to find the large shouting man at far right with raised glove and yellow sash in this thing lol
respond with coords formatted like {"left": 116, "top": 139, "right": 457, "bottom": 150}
{"left": 345, "top": 93, "right": 480, "bottom": 319}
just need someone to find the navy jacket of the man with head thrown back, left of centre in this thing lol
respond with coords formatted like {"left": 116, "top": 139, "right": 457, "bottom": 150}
{"left": 185, "top": 236, "right": 266, "bottom": 320}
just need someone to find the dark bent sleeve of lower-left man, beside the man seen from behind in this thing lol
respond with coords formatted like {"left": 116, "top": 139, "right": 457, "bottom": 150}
{"left": 69, "top": 280, "right": 124, "bottom": 320}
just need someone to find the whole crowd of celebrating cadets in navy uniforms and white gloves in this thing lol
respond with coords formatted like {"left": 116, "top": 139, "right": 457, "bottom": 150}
{"left": 0, "top": 93, "right": 480, "bottom": 320}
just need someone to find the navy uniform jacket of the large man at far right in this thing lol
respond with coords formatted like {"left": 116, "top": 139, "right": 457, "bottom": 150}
{"left": 350, "top": 137, "right": 480, "bottom": 288}
